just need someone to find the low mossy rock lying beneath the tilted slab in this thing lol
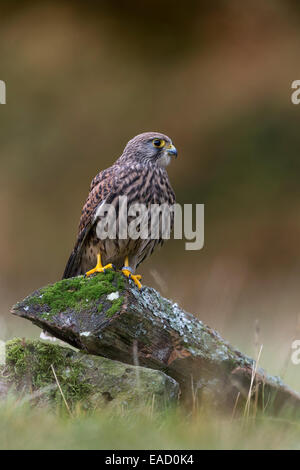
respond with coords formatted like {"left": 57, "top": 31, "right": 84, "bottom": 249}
{"left": 0, "top": 338, "right": 179, "bottom": 409}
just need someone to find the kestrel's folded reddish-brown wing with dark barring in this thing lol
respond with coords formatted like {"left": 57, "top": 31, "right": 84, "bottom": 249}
{"left": 63, "top": 167, "right": 116, "bottom": 279}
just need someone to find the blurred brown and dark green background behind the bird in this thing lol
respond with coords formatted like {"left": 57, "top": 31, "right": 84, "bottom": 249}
{"left": 0, "top": 0, "right": 300, "bottom": 389}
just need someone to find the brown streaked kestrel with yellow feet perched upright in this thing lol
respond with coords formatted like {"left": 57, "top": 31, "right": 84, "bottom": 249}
{"left": 63, "top": 132, "right": 177, "bottom": 288}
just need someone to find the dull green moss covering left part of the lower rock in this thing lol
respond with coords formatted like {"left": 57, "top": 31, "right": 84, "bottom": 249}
{"left": 6, "top": 339, "right": 92, "bottom": 406}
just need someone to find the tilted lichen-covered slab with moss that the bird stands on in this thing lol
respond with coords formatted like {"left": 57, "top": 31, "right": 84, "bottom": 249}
{"left": 12, "top": 272, "right": 300, "bottom": 414}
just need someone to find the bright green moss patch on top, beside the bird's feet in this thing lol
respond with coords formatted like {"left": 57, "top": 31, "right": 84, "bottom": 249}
{"left": 27, "top": 271, "right": 124, "bottom": 318}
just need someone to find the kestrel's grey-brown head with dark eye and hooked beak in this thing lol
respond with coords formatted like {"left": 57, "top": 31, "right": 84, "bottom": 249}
{"left": 121, "top": 132, "right": 177, "bottom": 167}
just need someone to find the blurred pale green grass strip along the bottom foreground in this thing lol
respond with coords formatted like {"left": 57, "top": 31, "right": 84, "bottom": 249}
{"left": 0, "top": 397, "right": 300, "bottom": 449}
